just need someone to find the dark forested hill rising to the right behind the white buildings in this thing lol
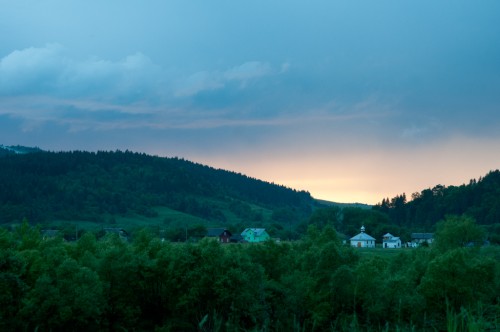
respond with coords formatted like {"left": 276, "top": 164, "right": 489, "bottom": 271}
{"left": 373, "top": 170, "right": 500, "bottom": 230}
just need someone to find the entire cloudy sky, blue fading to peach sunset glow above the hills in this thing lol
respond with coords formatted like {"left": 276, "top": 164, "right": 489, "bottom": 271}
{"left": 0, "top": 0, "right": 500, "bottom": 204}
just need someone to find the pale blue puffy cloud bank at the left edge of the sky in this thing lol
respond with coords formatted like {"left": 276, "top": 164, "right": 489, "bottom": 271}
{"left": 0, "top": 44, "right": 161, "bottom": 99}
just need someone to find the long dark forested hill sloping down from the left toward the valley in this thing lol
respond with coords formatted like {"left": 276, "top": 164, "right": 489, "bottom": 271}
{"left": 0, "top": 151, "right": 313, "bottom": 223}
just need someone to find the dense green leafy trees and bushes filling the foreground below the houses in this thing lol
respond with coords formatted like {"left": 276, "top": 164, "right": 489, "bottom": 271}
{"left": 0, "top": 217, "right": 500, "bottom": 331}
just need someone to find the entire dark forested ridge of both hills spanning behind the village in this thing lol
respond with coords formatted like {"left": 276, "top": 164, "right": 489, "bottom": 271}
{"left": 0, "top": 146, "right": 500, "bottom": 243}
